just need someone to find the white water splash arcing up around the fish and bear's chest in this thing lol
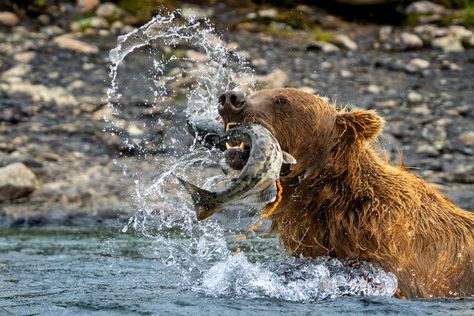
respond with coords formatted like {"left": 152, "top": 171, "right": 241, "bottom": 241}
{"left": 106, "top": 11, "right": 397, "bottom": 302}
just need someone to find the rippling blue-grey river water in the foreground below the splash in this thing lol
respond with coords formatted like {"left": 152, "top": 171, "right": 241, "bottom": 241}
{"left": 0, "top": 228, "right": 474, "bottom": 315}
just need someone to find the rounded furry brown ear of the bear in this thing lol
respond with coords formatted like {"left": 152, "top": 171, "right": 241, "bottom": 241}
{"left": 336, "top": 110, "right": 384, "bottom": 141}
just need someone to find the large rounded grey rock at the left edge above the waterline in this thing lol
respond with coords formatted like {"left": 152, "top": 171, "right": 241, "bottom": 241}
{"left": 0, "top": 163, "right": 37, "bottom": 201}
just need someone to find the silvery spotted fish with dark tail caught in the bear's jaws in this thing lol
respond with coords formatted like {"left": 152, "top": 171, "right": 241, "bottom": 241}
{"left": 178, "top": 125, "right": 296, "bottom": 220}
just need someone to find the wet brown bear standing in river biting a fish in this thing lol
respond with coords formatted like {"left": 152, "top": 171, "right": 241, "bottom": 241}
{"left": 218, "top": 89, "right": 474, "bottom": 298}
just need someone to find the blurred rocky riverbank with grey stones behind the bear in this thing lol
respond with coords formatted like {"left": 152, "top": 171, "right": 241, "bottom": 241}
{"left": 0, "top": 1, "right": 474, "bottom": 226}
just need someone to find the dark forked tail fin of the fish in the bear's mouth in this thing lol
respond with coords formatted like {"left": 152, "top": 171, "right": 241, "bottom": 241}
{"left": 173, "top": 174, "right": 219, "bottom": 221}
